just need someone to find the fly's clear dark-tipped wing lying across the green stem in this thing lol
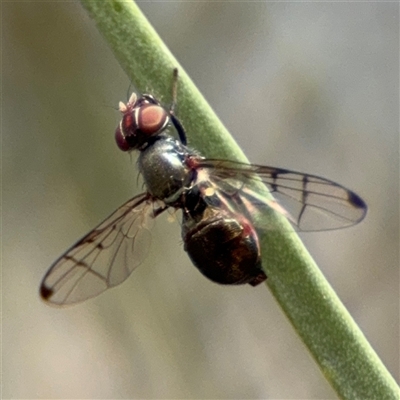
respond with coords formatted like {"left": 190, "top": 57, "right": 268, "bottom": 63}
{"left": 198, "top": 159, "right": 367, "bottom": 231}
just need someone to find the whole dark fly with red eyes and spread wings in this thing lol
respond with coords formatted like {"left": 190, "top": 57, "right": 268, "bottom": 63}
{"left": 40, "top": 70, "right": 367, "bottom": 305}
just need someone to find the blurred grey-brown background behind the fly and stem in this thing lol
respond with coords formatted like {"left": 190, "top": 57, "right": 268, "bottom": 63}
{"left": 2, "top": 2, "right": 399, "bottom": 399}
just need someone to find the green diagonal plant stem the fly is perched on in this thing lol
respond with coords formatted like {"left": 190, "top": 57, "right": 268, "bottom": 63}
{"left": 81, "top": 0, "right": 400, "bottom": 400}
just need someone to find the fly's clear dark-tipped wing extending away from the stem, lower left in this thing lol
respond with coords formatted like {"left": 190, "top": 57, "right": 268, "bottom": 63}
{"left": 40, "top": 193, "right": 154, "bottom": 305}
